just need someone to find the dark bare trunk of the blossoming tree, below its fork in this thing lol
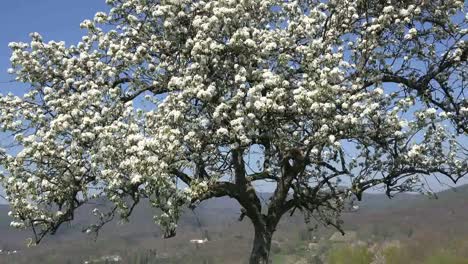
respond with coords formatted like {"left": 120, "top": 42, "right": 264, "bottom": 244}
{"left": 249, "top": 224, "right": 273, "bottom": 264}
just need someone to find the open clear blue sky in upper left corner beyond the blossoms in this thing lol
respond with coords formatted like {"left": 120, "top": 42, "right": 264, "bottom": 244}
{"left": 0, "top": 0, "right": 108, "bottom": 93}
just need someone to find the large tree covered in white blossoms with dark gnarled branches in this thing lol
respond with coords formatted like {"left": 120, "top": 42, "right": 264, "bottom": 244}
{"left": 0, "top": 0, "right": 468, "bottom": 263}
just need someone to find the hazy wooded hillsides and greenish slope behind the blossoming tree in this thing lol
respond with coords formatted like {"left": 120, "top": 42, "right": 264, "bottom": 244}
{"left": 0, "top": 185, "right": 468, "bottom": 264}
